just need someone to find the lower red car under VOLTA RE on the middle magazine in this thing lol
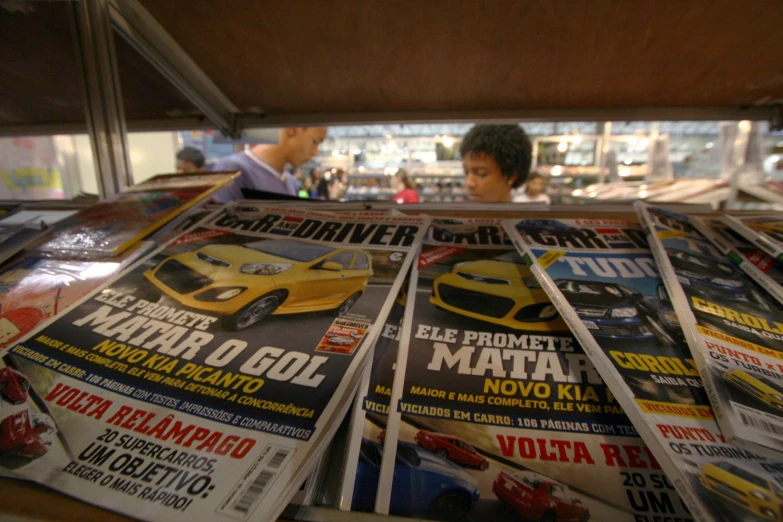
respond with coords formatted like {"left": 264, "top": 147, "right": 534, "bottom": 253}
{"left": 492, "top": 471, "right": 590, "bottom": 522}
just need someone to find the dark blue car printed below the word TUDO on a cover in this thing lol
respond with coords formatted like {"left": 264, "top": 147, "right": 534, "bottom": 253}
{"left": 555, "top": 279, "right": 675, "bottom": 344}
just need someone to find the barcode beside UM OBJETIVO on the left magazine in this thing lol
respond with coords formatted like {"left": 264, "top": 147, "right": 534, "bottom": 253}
{"left": 217, "top": 445, "right": 294, "bottom": 520}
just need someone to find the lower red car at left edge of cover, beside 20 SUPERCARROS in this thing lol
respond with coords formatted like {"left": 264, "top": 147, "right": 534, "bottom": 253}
{"left": 0, "top": 410, "right": 55, "bottom": 467}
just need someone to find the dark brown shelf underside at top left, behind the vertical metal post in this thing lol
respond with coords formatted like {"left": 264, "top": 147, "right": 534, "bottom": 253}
{"left": 0, "top": 2, "right": 199, "bottom": 132}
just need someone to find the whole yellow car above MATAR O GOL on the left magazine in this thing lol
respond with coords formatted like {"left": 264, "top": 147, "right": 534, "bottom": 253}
{"left": 144, "top": 239, "right": 373, "bottom": 330}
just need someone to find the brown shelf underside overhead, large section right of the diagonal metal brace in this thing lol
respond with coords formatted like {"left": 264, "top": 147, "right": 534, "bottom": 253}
{"left": 141, "top": 0, "right": 783, "bottom": 115}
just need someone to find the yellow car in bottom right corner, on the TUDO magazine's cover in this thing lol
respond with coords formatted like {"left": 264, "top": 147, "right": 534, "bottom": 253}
{"left": 699, "top": 462, "right": 783, "bottom": 520}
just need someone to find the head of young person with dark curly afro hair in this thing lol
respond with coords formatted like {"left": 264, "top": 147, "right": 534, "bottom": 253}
{"left": 460, "top": 125, "right": 533, "bottom": 203}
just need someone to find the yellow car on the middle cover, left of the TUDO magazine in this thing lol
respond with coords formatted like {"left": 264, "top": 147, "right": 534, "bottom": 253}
{"left": 430, "top": 252, "right": 567, "bottom": 331}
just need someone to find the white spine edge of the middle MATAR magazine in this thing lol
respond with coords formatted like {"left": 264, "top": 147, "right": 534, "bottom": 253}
{"left": 375, "top": 258, "right": 421, "bottom": 515}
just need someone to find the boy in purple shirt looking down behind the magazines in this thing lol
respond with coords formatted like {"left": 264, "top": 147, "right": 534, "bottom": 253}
{"left": 212, "top": 127, "right": 326, "bottom": 203}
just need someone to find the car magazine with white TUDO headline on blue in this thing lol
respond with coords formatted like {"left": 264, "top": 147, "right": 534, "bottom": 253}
{"left": 504, "top": 215, "right": 783, "bottom": 522}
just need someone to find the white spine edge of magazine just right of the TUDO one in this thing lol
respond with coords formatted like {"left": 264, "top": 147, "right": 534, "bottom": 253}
{"left": 634, "top": 202, "right": 738, "bottom": 438}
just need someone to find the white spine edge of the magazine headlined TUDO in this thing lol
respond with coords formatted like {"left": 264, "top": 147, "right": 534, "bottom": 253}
{"left": 506, "top": 220, "right": 712, "bottom": 522}
